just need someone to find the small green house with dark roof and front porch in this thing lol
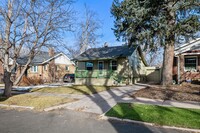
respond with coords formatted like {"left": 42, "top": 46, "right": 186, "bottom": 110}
{"left": 74, "top": 45, "right": 146, "bottom": 86}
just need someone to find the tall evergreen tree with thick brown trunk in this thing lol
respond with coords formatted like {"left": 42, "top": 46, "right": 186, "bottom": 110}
{"left": 111, "top": 0, "right": 200, "bottom": 85}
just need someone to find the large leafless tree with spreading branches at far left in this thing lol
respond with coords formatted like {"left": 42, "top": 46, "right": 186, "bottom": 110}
{"left": 0, "top": 0, "right": 73, "bottom": 97}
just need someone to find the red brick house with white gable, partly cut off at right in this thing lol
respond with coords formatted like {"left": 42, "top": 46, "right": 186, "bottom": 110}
{"left": 173, "top": 38, "right": 200, "bottom": 83}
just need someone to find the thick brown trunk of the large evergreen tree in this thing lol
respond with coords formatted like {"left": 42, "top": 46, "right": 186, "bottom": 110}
{"left": 162, "top": 42, "right": 174, "bottom": 85}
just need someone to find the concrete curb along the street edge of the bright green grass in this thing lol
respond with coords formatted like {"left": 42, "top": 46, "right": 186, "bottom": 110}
{"left": 100, "top": 115, "right": 200, "bottom": 133}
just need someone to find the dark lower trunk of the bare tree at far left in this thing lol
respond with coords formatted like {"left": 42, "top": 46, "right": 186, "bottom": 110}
{"left": 3, "top": 70, "right": 13, "bottom": 97}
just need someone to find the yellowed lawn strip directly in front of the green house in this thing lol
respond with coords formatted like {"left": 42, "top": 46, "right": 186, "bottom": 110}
{"left": 31, "top": 85, "right": 110, "bottom": 95}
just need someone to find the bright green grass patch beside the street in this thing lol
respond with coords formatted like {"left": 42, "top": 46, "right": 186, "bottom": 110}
{"left": 106, "top": 103, "right": 200, "bottom": 129}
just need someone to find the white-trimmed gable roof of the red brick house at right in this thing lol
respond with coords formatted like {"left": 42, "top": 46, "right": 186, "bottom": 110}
{"left": 174, "top": 38, "right": 200, "bottom": 55}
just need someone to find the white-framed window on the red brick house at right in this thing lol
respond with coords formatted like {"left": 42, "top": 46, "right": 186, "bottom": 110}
{"left": 185, "top": 57, "right": 197, "bottom": 71}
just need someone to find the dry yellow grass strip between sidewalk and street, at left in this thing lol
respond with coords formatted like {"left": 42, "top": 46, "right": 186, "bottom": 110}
{"left": 0, "top": 94, "right": 75, "bottom": 110}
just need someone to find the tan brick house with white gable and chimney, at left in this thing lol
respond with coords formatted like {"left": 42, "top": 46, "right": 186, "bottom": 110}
{"left": 16, "top": 50, "right": 75, "bottom": 82}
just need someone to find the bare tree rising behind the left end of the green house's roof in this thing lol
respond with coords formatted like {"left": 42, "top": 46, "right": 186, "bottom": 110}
{"left": 66, "top": 5, "right": 102, "bottom": 57}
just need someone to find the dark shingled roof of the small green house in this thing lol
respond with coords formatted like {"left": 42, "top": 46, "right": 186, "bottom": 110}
{"left": 73, "top": 46, "right": 136, "bottom": 61}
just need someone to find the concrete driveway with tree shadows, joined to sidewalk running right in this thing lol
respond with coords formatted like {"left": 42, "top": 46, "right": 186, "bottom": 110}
{"left": 58, "top": 85, "right": 200, "bottom": 114}
